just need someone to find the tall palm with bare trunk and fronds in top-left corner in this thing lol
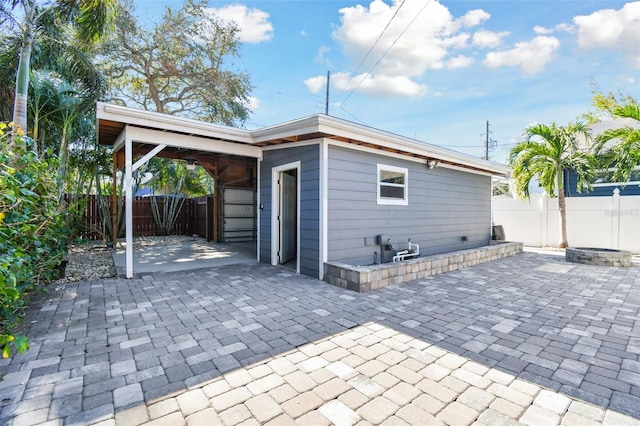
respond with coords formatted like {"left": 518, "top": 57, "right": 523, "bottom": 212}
{"left": 0, "top": 0, "right": 117, "bottom": 136}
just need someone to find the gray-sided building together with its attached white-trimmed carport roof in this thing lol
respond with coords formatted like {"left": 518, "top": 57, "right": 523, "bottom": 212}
{"left": 97, "top": 103, "right": 510, "bottom": 278}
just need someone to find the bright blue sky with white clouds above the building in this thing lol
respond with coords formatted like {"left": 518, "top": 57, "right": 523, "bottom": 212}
{"left": 135, "top": 0, "right": 640, "bottom": 162}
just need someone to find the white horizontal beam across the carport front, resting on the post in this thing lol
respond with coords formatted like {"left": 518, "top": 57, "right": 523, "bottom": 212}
{"left": 125, "top": 125, "right": 262, "bottom": 159}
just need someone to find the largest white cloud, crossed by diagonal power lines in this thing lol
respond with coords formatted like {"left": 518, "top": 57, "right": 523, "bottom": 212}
{"left": 322, "top": 0, "right": 490, "bottom": 96}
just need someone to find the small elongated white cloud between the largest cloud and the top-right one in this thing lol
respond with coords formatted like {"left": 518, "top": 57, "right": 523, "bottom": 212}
{"left": 484, "top": 36, "right": 560, "bottom": 74}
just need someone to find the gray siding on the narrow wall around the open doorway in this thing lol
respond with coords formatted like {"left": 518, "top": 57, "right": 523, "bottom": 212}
{"left": 259, "top": 145, "right": 320, "bottom": 277}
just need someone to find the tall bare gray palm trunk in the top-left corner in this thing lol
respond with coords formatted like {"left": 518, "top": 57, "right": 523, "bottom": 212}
{"left": 13, "top": 0, "right": 36, "bottom": 136}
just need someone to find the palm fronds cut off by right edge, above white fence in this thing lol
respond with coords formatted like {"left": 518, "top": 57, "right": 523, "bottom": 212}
{"left": 596, "top": 99, "right": 640, "bottom": 186}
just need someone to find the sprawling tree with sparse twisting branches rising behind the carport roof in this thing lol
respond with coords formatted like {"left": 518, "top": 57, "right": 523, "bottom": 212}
{"left": 101, "top": 0, "right": 251, "bottom": 125}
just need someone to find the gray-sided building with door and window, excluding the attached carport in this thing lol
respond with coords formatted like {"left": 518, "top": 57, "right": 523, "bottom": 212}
{"left": 253, "top": 115, "right": 510, "bottom": 277}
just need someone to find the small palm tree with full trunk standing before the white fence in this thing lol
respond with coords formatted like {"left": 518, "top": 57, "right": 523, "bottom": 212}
{"left": 509, "top": 122, "right": 598, "bottom": 248}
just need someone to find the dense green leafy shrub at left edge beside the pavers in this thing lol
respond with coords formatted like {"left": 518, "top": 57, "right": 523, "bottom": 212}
{"left": 0, "top": 123, "right": 66, "bottom": 358}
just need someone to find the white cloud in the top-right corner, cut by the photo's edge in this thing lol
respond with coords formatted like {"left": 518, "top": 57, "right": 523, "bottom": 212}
{"left": 573, "top": 1, "right": 640, "bottom": 68}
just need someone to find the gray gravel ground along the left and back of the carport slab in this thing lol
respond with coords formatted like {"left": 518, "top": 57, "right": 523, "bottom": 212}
{"left": 55, "top": 235, "right": 204, "bottom": 283}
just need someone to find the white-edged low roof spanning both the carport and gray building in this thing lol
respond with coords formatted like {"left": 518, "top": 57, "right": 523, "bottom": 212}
{"left": 96, "top": 102, "right": 511, "bottom": 176}
